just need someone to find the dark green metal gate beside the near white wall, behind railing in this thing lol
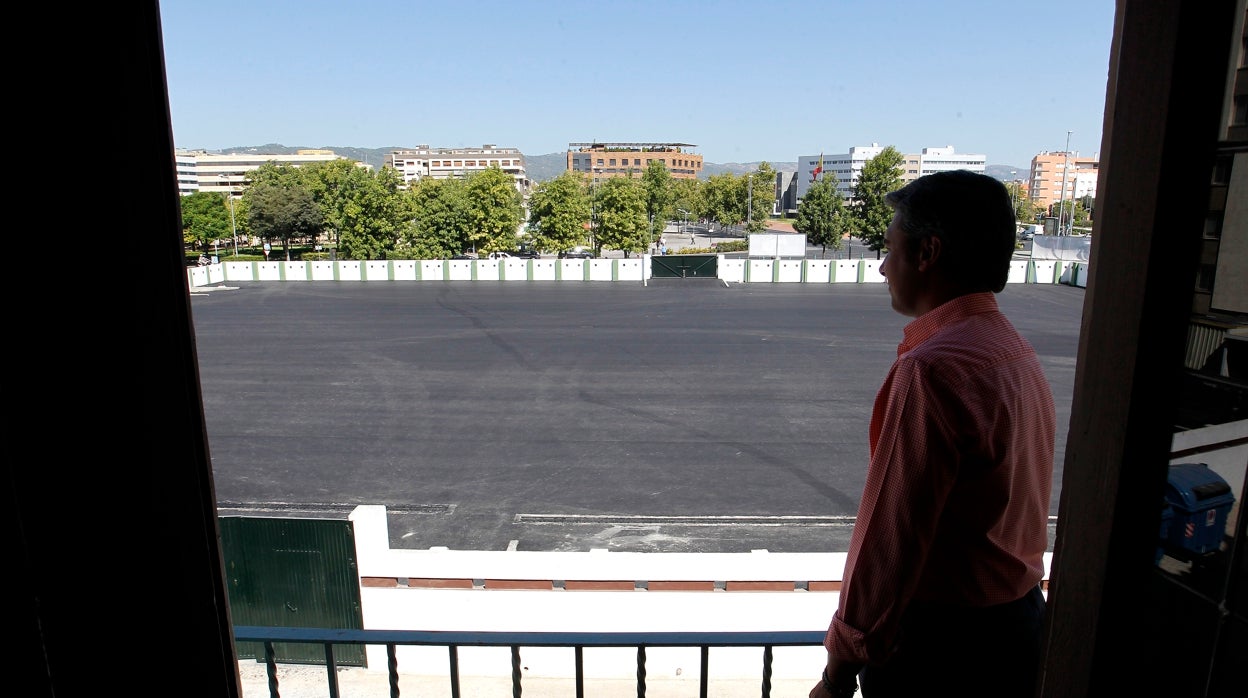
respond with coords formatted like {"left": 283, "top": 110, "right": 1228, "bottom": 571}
{"left": 220, "top": 517, "right": 366, "bottom": 667}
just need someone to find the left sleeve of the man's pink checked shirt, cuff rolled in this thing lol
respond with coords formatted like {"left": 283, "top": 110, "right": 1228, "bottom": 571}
{"left": 824, "top": 356, "right": 957, "bottom": 663}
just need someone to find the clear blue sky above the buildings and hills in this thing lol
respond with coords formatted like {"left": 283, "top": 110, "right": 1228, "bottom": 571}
{"left": 161, "top": 0, "right": 1113, "bottom": 167}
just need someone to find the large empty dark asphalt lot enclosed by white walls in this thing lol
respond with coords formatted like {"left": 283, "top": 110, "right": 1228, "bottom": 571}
{"left": 191, "top": 280, "right": 1085, "bottom": 552}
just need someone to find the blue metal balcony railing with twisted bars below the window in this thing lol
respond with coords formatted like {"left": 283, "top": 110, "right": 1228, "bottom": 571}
{"left": 235, "top": 626, "right": 824, "bottom": 698}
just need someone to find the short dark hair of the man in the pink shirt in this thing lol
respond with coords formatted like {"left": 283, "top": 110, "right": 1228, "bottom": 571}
{"left": 884, "top": 170, "right": 1017, "bottom": 292}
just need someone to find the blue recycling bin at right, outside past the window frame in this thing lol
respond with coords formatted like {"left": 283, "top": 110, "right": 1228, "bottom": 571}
{"left": 1166, "top": 463, "right": 1236, "bottom": 554}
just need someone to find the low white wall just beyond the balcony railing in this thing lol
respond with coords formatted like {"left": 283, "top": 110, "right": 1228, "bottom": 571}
{"left": 351, "top": 506, "right": 1051, "bottom": 684}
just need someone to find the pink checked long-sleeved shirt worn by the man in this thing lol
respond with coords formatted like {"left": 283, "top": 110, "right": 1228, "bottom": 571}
{"left": 824, "top": 292, "right": 1056, "bottom": 663}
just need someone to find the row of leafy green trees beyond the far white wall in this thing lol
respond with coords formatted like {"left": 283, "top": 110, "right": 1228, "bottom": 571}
{"left": 182, "top": 146, "right": 1048, "bottom": 260}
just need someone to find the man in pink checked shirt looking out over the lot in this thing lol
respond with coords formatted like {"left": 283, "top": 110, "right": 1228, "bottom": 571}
{"left": 810, "top": 171, "right": 1056, "bottom": 698}
